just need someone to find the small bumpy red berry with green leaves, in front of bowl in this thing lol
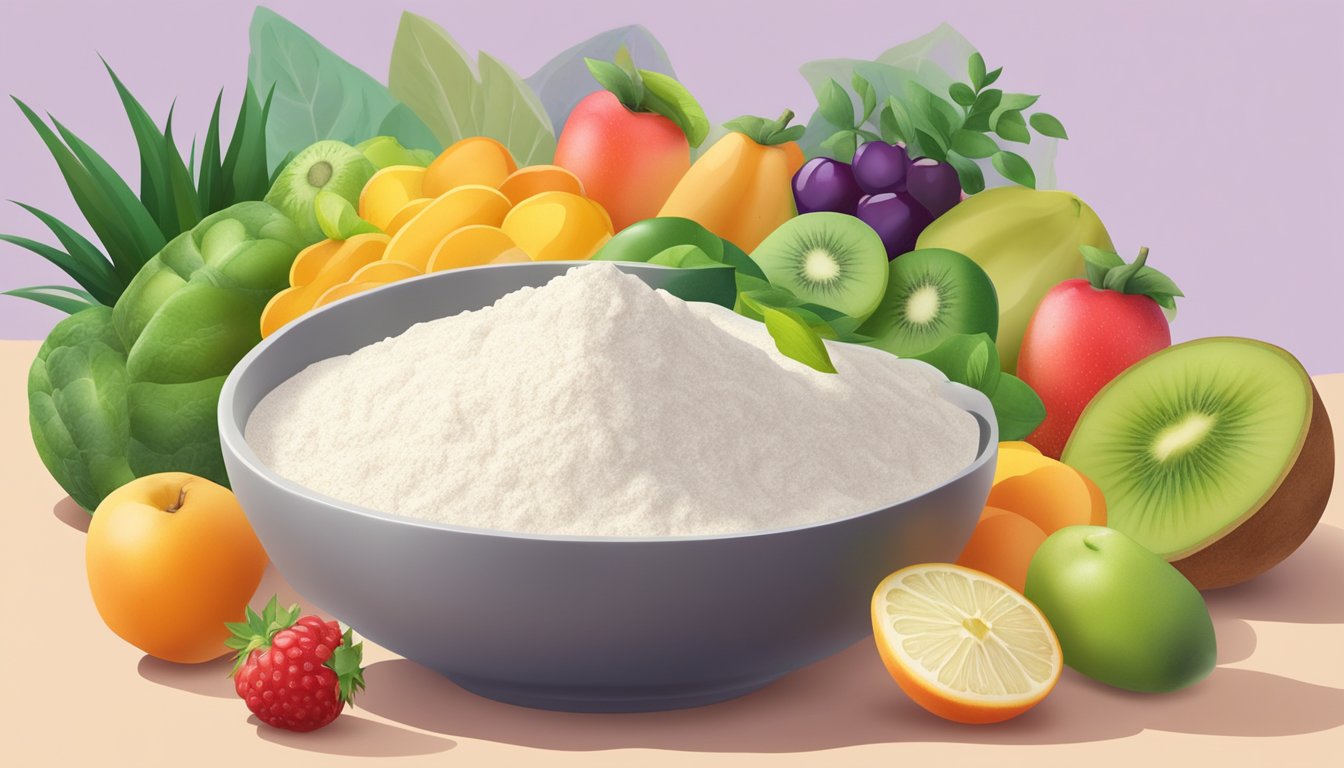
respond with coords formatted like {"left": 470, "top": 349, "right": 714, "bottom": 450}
{"left": 224, "top": 597, "right": 364, "bottom": 732}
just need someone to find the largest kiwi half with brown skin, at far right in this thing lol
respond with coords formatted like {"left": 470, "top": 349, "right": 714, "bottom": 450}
{"left": 1063, "top": 338, "right": 1335, "bottom": 589}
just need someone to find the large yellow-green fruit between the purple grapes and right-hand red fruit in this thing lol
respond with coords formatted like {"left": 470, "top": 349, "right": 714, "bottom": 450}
{"left": 913, "top": 186, "right": 1116, "bottom": 373}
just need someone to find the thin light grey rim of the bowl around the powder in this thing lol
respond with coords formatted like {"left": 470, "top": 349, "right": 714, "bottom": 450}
{"left": 216, "top": 260, "right": 999, "bottom": 543}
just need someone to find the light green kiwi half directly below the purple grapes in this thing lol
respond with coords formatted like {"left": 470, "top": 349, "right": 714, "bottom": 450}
{"left": 750, "top": 211, "right": 887, "bottom": 320}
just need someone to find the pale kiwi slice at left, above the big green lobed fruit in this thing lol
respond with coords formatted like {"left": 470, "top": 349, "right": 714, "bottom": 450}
{"left": 266, "top": 140, "right": 376, "bottom": 242}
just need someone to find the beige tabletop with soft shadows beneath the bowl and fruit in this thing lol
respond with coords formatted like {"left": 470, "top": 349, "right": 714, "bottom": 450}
{"left": 0, "top": 342, "right": 1344, "bottom": 768}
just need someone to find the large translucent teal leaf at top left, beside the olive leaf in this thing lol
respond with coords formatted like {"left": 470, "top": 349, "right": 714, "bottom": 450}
{"left": 247, "top": 7, "right": 400, "bottom": 169}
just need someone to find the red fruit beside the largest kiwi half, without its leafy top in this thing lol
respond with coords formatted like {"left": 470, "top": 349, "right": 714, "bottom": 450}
{"left": 1017, "top": 280, "right": 1172, "bottom": 459}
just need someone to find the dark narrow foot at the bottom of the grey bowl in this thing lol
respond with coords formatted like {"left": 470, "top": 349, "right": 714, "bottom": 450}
{"left": 445, "top": 674, "right": 784, "bottom": 713}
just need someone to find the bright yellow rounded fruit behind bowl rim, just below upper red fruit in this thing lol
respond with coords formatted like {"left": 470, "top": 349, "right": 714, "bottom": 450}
{"left": 500, "top": 192, "right": 613, "bottom": 261}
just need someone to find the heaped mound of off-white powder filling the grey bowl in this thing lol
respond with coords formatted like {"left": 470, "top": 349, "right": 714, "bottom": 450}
{"left": 246, "top": 264, "right": 978, "bottom": 537}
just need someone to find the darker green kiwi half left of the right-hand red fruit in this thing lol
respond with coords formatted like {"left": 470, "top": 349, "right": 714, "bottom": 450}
{"left": 859, "top": 247, "right": 999, "bottom": 355}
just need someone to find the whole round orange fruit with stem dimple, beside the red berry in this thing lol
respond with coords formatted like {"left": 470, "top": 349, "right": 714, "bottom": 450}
{"left": 85, "top": 472, "right": 266, "bottom": 663}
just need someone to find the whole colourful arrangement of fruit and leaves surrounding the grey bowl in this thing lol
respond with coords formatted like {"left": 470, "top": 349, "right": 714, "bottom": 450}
{"left": 0, "top": 9, "right": 1333, "bottom": 729}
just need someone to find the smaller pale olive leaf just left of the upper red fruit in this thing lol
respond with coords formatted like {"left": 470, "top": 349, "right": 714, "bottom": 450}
{"left": 477, "top": 51, "right": 555, "bottom": 168}
